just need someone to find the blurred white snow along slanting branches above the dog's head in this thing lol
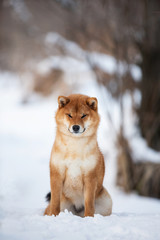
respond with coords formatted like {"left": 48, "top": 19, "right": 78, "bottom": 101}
{"left": 44, "top": 32, "right": 142, "bottom": 82}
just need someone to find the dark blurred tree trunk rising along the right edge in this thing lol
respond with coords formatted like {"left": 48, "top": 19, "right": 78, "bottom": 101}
{"left": 139, "top": 1, "right": 160, "bottom": 150}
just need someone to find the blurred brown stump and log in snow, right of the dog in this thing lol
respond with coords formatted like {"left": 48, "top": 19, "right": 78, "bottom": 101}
{"left": 117, "top": 132, "right": 160, "bottom": 198}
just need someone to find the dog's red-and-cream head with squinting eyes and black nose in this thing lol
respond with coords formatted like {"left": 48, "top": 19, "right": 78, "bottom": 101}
{"left": 56, "top": 94, "right": 99, "bottom": 137}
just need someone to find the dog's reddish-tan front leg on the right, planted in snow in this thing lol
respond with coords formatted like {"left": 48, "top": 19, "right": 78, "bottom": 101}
{"left": 84, "top": 175, "right": 96, "bottom": 217}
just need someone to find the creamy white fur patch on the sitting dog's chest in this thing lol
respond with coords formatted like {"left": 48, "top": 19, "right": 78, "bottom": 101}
{"left": 51, "top": 135, "right": 98, "bottom": 178}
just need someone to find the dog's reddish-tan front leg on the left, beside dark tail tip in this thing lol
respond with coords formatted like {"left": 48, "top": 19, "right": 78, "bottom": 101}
{"left": 49, "top": 166, "right": 62, "bottom": 216}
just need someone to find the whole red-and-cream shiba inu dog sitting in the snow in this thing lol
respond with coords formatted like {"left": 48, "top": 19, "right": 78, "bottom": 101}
{"left": 44, "top": 94, "right": 112, "bottom": 217}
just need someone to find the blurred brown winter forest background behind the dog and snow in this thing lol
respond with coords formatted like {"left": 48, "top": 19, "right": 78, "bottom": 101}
{"left": 0, "top": 0, "right": 160, "bottom": 198}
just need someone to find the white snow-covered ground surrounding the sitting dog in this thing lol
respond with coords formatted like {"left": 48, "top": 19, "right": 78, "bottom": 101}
{"left": 0, "top": 71, "right": 160, "bottom": 240}
